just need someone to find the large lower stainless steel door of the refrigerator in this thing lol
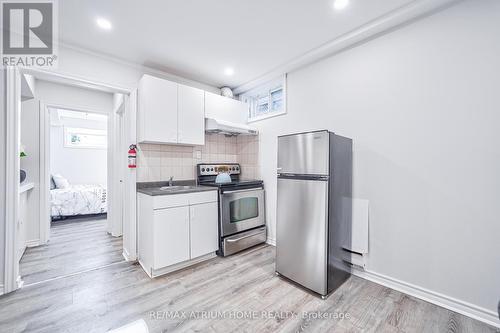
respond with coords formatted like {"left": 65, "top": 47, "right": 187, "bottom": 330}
{"left": 276, "top": 178, "right": 328, "bottom": 295}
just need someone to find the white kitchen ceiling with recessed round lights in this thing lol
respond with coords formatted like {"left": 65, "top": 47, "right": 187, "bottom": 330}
{"left": 59, "top": 0, "right": 414, "bottom": 87}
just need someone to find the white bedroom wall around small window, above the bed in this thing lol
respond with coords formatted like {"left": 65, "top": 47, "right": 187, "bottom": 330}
{"left": 50, "top": 115, "right": 107, "bottom": 186}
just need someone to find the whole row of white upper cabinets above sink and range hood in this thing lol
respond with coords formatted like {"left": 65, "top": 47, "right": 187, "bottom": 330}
{"left": 137, "top": 75, "right": 248, "bottom": 145}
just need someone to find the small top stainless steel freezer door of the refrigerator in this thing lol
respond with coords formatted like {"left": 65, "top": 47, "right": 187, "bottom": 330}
{"left": 278, "top": 131, "right": 330, "bottom": 175}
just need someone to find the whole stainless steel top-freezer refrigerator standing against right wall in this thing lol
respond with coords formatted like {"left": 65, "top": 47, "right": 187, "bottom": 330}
{"left": 276, "top": 130, "right": 352, "bottom": 297}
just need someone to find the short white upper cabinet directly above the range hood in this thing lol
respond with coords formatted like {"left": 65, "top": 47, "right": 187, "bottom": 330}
{"left": 205, "top": 92, "right": 248, "bottom": 124}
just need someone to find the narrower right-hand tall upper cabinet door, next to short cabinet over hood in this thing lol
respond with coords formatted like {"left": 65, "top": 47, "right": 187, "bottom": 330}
{"left": 177, "top": 85, "right": 205, "bottom": 145}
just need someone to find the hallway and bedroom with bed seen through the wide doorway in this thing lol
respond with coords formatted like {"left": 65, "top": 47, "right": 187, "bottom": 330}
{"left": 19, "top": 79, "right": 123, "bottom": 285}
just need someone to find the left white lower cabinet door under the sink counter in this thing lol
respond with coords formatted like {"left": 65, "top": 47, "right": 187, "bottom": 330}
{"left": 153, "top": 206, "right": 189, "bottom": 269}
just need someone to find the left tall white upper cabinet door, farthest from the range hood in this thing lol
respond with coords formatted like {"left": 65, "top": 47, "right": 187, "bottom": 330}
{"left": 138, "top": 75, "right": 177, "bottom": 143}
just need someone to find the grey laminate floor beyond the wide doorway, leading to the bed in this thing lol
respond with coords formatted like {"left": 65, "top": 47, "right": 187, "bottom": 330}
{"left": 19, "top": 219, "right": 124, "bottom": 284}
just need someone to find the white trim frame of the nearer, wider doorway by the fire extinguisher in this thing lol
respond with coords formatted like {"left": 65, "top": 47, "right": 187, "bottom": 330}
{"left": 0, "top": 67, "right": 137, "bottom": 295}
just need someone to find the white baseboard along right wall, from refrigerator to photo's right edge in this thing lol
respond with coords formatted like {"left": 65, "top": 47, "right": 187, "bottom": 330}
{"left": 352, "top": 269, "right": 500, "bottom": 328}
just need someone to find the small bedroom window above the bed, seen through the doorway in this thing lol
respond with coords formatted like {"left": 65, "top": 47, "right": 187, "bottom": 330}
{"left": 64, "top": 127, "right": 108, "bottom": 149}
